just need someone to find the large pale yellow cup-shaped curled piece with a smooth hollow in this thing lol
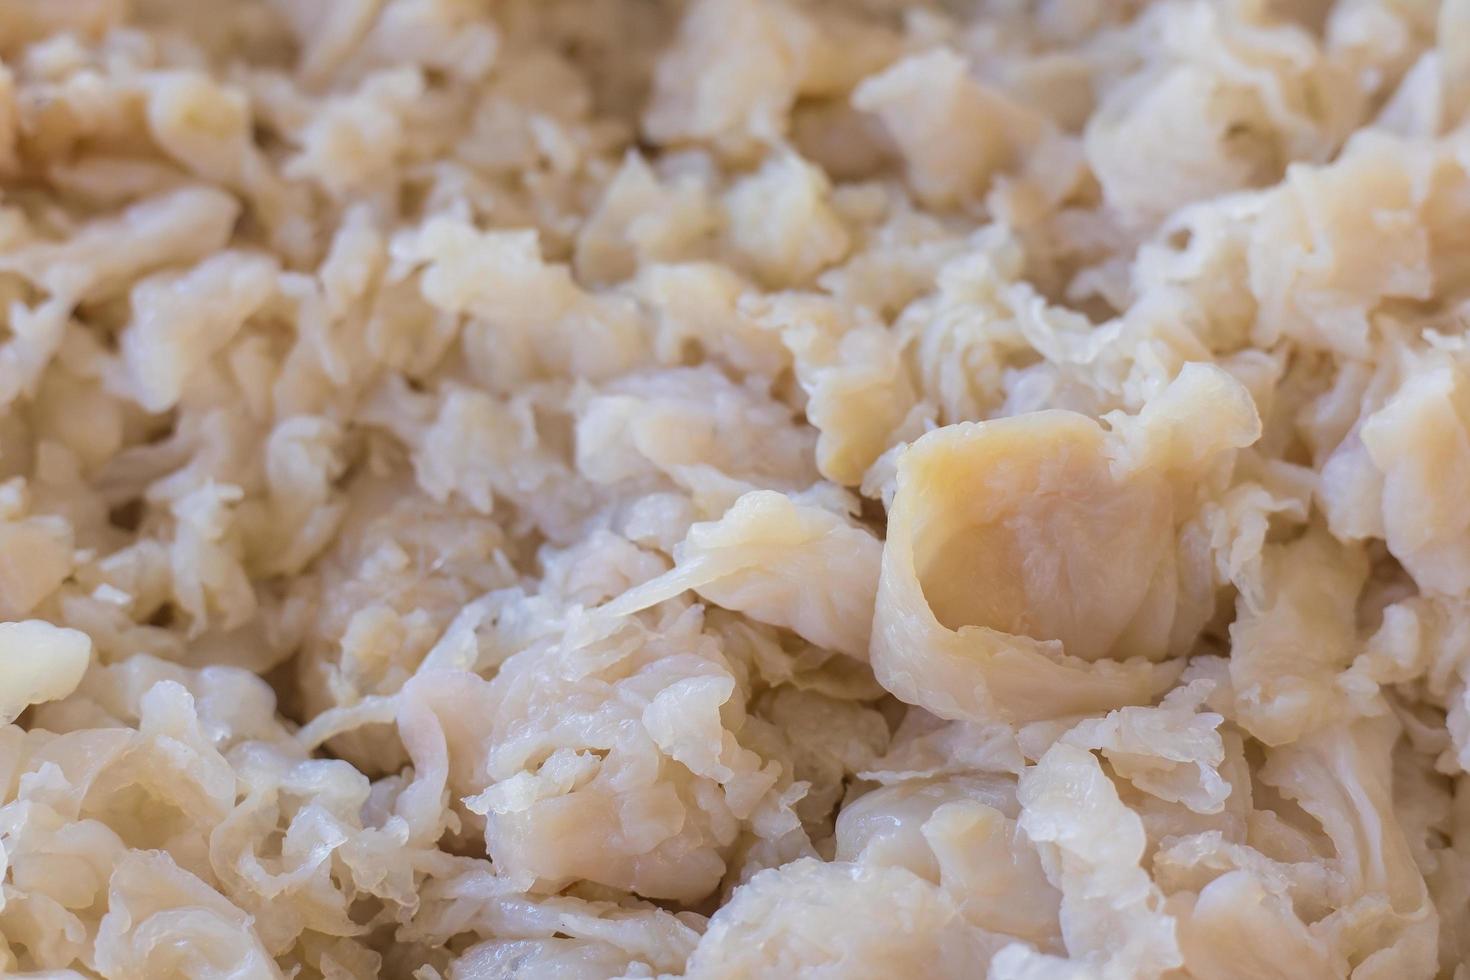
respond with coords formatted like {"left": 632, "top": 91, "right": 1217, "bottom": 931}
{"left": 872, "top": 366, "right": 1260, "bottom": 721}
